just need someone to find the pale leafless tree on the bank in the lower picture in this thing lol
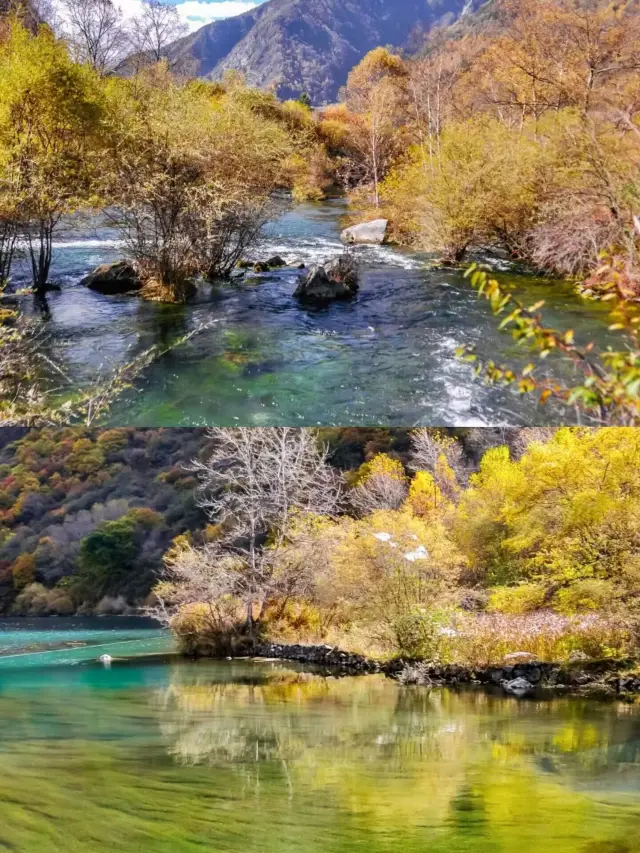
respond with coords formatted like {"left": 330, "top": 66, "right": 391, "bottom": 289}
{"left": 157, "top": 427, "right": 340, "bottom": 637}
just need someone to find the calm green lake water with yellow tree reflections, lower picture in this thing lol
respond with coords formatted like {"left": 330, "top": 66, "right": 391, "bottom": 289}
{"left": 0, "top": 620, "right": 640, "bottom": 853}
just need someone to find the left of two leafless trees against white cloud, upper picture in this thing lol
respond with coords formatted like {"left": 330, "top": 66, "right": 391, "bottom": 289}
{"left": 61, "top": 0, "right": 130, "bottom": 74}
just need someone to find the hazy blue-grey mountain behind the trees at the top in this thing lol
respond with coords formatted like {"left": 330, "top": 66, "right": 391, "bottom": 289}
{"left": 169, "top": 0, "right": 484, "bottom": 105}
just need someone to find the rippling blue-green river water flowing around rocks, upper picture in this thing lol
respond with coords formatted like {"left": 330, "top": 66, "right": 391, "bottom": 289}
{"left": 15, "top": 201, "right": 607, "bottom": 426}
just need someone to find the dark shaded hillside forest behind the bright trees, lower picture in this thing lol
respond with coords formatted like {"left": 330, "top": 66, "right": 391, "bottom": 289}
{"left": 0, "top": 428, "right": 416, "bottom": 614}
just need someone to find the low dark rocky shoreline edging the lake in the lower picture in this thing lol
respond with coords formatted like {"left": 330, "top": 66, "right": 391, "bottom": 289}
{"left": 254, "top": 643, "right": 640, "bottom": 698}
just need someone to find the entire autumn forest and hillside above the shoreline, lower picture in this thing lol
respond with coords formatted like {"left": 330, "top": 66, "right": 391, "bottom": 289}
{"left": 5, "top": 428, "right": 640, "bottom": 664}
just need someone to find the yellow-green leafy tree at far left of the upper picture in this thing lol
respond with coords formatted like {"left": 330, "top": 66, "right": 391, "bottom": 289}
{"left": 0, "top": 21, "right": 102, "bottom": 297}
